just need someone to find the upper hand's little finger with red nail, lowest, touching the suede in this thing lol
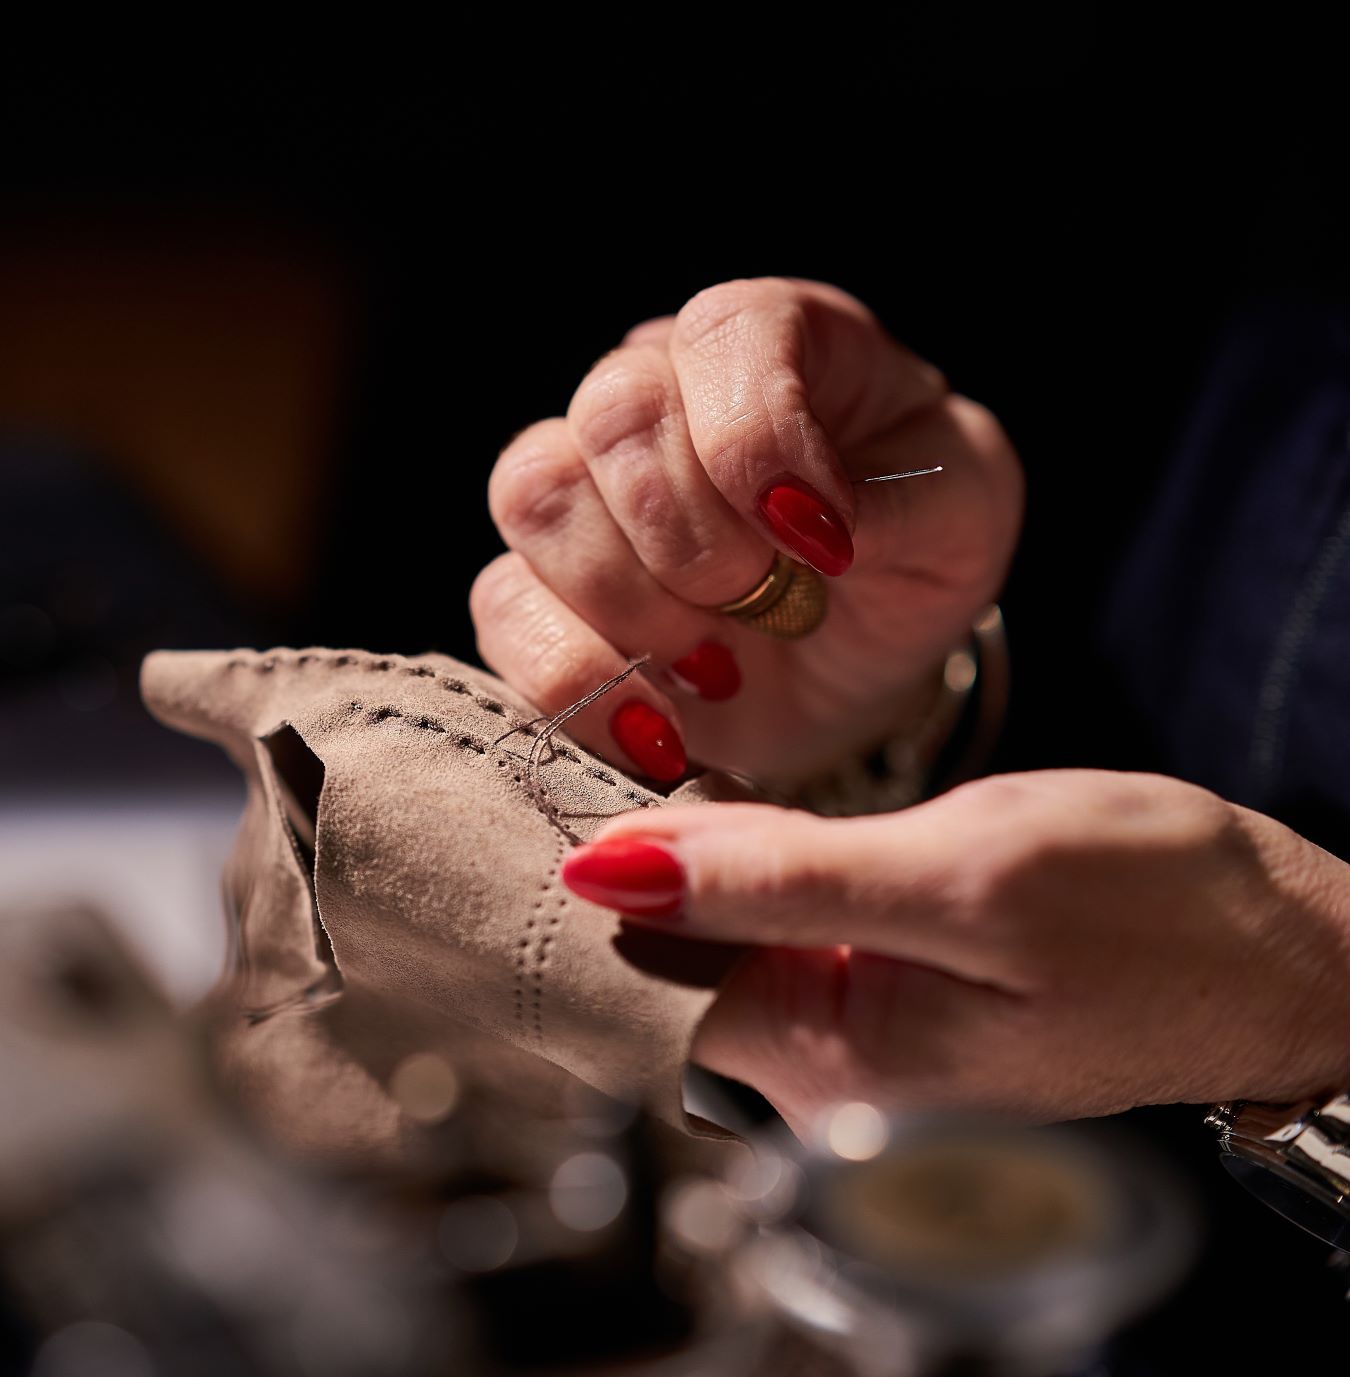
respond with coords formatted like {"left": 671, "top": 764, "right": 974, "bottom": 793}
{"left": 468, "top": 552, "right": 687, "bottom": 782}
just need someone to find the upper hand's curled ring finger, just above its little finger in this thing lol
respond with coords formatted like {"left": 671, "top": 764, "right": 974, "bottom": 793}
{"left": 488, "top": 420, "right": 734, "bottom": 697}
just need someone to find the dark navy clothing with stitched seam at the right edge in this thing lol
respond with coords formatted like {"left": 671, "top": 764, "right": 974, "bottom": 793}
{"left": 1106, "top": 303, "right": 1350, "bottom": 859}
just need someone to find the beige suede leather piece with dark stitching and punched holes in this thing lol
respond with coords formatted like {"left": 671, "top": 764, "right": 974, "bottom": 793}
{"left": 142, "top": 649, "right": 747, "bottom": 1155}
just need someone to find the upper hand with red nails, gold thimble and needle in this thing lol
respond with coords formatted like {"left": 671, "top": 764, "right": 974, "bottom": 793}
{"left": 470, "top": 278, "right": 1022, "bottom": 785}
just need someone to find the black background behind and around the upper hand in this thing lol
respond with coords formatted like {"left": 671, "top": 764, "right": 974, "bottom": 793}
{"left": 0, "top": 26, "right": 1347, "bottom": 1371}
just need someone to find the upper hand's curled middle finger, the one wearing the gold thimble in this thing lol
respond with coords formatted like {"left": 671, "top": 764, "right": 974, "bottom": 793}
{"left": 568, "top": 344, "right": 773, "bottom": 606}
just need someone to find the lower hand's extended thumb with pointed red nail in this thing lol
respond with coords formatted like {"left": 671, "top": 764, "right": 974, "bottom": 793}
{"left": 562, "top": 804, "right": 1022, "bottom": 989}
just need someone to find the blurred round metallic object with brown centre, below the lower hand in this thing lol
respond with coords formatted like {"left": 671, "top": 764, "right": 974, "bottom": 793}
{"left": 730, "top": 1103, "right": 1196, "bottom": 1377}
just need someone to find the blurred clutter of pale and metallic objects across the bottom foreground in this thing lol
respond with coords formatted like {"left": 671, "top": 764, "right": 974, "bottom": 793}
{"left": 0, "top": 906, "right": 1190, "bottom": 1377}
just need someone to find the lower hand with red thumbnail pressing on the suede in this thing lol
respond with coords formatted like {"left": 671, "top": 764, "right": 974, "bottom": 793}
{"left": 563, "top": 770, "right": 1350, "bottom": 1126}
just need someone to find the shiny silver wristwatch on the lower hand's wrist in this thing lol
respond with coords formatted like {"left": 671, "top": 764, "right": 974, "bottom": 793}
{"left": 1205, "top": 1095, "right": 1350, "bottom": 1250}
